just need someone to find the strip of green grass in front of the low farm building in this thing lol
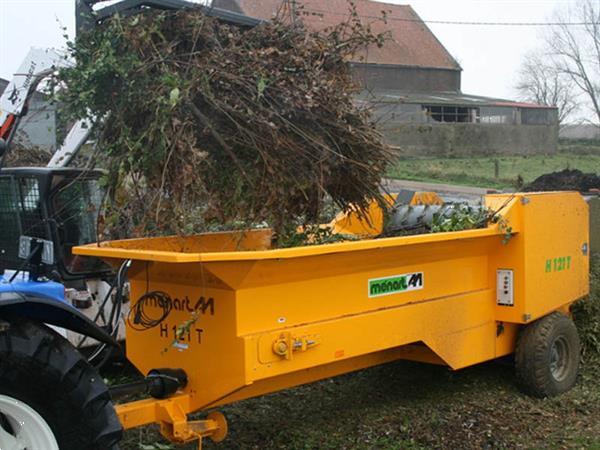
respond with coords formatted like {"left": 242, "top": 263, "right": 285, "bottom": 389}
{"left": 388, "top": 151, "right": 600, "bottom": 189}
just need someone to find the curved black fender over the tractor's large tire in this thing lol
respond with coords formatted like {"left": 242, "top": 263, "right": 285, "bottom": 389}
{"left": 0, "top": 292, "right": 119, "bottom": 347}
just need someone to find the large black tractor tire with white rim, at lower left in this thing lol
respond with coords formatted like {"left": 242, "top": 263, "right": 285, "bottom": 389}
{"left": 0, "top": 320, "right": 122, "bottom": 450}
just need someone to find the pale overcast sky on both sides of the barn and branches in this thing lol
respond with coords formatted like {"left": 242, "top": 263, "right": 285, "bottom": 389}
{"left": 0, "top": 0, "right": 575, "bottom": 98}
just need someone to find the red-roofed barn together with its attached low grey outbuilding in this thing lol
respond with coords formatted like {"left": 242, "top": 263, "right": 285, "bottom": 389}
{"left": 212, "top": 0, "right": 558, "bottom": 155}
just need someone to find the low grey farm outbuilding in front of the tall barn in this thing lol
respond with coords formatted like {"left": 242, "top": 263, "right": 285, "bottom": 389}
{"left": 368, "top": 91, "right": 558, "bottom": 156}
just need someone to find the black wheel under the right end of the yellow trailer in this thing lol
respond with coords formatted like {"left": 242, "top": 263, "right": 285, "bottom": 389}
{"left": 515, "top": 312, "right": 581, "bottom": 398}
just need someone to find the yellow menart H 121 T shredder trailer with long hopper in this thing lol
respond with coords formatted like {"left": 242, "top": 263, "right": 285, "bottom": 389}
{"left": 75, "top": 192, "right": 589, "bottom": 444}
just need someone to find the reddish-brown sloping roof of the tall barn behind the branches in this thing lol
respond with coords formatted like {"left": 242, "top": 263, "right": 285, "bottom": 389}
{"left": 218, "top": 0, "right": 461, "bottom": 70}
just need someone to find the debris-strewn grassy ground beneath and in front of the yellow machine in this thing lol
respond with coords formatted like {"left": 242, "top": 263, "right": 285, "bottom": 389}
{"left": 113, "top": 255, "right": 600, "bottom": 450}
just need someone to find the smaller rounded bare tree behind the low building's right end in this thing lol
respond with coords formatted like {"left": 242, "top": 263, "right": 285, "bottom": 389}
{"left": 516, "top": 52, "right": 579, "bottom": 124}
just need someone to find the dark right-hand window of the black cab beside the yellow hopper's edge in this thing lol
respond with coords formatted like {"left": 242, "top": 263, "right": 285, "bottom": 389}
{"left": 52, "top": 178, "right": 109, "bottom": 274}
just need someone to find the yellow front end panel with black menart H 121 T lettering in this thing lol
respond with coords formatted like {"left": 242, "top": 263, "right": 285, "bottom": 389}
{"left": 127, "top": 261, "right": 246, "bottom": 416}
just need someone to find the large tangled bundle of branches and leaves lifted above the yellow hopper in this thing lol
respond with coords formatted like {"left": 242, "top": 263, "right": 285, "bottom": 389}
{"left": 53, "top": 4, "right": 390, "bottom": 243}
